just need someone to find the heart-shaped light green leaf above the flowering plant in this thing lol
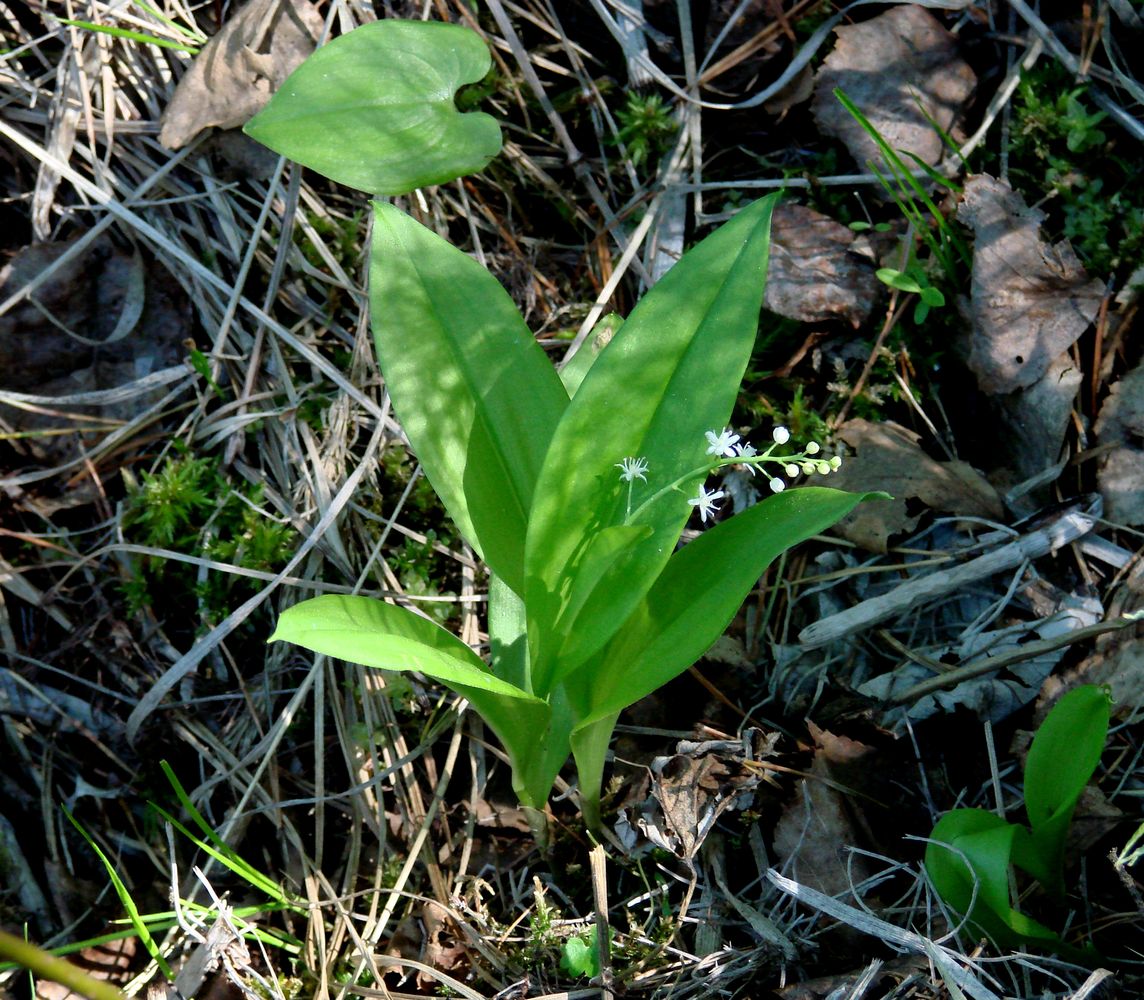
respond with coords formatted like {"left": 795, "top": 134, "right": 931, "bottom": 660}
{"left": 244, "top": 21, "right": 501, "bottom": 195}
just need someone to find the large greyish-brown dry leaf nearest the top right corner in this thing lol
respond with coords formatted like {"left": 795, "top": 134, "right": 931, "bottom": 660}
{"left": 813, "top": 5, "right": 977, "bottom": 167}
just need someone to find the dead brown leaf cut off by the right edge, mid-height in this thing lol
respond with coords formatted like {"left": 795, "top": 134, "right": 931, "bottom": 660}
{"left": 1095, "top": 363, "right": 1144, "bottom": 525}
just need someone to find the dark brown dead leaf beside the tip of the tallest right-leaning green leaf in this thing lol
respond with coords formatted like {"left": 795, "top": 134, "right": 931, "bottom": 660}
{"left": 765, "top": 205, "right": 881, "bottom": 330}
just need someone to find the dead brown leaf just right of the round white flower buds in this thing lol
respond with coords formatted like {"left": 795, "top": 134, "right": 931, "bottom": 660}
{"left": 831, "top": 419, "right": 1004, "bottom": 553}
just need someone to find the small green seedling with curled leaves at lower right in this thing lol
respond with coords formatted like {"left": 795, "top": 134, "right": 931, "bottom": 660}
{"left": 925, "top": 684, "right": 1110, "bottom": 953}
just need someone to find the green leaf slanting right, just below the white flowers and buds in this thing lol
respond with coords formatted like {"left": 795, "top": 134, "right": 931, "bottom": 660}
{"left": 569, "top": 486, "right": 884, "bottom": 724}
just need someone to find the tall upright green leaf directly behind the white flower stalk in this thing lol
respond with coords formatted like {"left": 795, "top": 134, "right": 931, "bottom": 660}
{"left": 524, "top": 197, "right": 774, "bottom": 692}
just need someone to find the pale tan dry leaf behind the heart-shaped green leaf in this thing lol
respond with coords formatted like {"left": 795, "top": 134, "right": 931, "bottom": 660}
{"left": 159, "top": 0, "right": 323, "bottom": 149}
